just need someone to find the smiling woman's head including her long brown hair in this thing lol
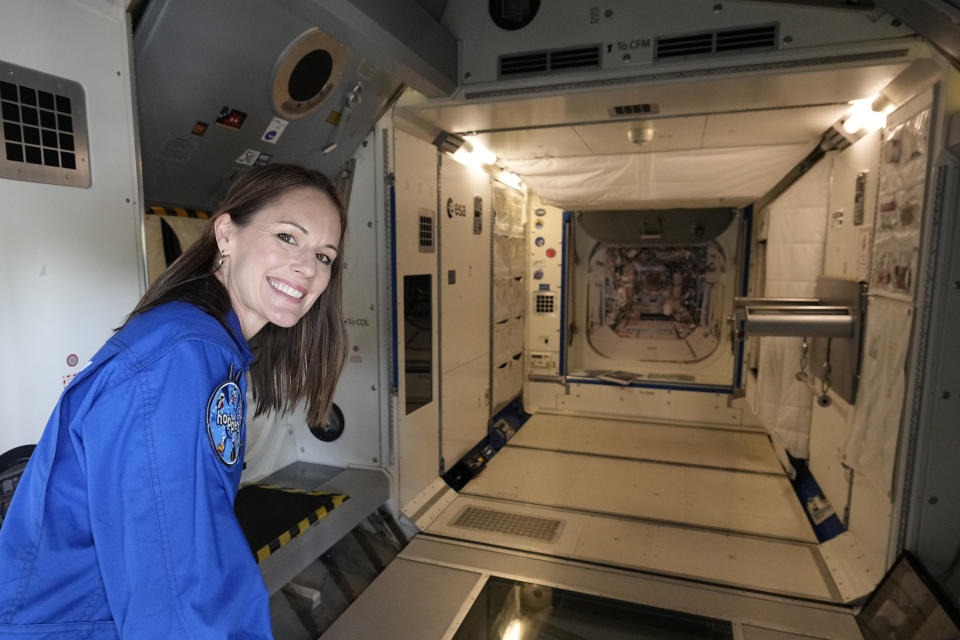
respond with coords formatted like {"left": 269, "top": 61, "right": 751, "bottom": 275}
{"left": 130, "top": 164, "right": 347, "bottom": 424}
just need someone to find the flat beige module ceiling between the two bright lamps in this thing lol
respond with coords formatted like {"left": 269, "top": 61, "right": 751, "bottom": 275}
{"left": 401, "top": 61, "right": 907, "bottom": 160}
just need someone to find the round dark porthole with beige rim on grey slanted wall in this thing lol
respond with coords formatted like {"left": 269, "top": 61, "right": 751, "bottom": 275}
{"left": 273, "top": 29, "right": 347, "bottom": 119}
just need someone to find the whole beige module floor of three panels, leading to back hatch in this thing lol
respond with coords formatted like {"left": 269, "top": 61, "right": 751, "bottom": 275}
{"left": 427, "top": 414, "right": 839, "bottom": 602}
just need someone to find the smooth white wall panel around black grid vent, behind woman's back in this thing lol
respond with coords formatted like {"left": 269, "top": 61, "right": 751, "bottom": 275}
{"left": 0, "top": 0, "right": 145, "bottom": 453}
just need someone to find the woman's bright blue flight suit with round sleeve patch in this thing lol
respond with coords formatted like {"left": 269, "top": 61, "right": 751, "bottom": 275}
{"left": 0, "top": 302, "right": 272, "bottom": 640}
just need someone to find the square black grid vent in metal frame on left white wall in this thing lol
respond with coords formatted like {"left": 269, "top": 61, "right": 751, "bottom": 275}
{"left": 0, "top": 61, "right": 90, "bottom": 187}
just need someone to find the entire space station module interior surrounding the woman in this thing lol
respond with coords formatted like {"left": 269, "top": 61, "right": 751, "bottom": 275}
{"left": 0, "top": 0, "right": 960, "bottom": 638}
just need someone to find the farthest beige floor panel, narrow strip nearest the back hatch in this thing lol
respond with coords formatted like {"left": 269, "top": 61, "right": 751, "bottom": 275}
{"left": 510, "top": 413, "right": 783, "bottom": 474}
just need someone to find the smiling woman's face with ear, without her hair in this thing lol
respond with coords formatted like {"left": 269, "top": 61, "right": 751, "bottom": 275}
{"left": 214, "top": 187, "right": 340, "bottom": 340}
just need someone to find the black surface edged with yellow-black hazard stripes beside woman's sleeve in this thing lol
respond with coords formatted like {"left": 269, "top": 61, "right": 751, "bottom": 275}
{"left": 234, "top": 484, "right": 349, "bottom": 563}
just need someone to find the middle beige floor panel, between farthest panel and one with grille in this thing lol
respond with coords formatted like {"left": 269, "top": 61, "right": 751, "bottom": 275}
{"left": 463, "top": 446, "right": 816, "bottom": 542}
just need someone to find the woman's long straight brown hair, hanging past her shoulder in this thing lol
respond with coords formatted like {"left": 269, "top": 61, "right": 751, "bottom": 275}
{"left": 124, "top": 164, "right": 347, "bottom": 425}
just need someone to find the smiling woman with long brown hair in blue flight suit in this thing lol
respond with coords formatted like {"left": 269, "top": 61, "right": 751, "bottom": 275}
{"left": 0, "top": 165, "right": 346, "bottom": 639}
